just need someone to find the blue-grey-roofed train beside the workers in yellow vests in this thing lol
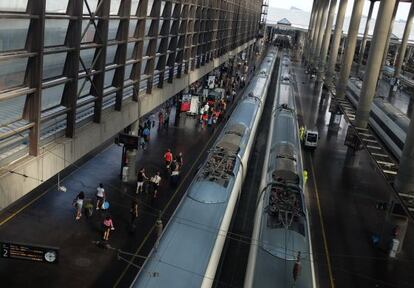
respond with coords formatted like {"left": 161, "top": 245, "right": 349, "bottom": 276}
{"left": 244, "top": 55, "right": 316, "bottom": 288}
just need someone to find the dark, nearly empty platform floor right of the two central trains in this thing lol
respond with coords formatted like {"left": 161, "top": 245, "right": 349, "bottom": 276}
{"left": 293, "top": 64, "right": 414, "bottom": 288}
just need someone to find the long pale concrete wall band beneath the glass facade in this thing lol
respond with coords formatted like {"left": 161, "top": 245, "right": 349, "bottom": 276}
{"left": 0, "top": 41, "right": 254, "bottom": 210}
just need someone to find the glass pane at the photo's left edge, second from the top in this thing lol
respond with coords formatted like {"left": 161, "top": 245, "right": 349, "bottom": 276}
{"left": 0, "top": 19, "right": 30, "bottom": 52}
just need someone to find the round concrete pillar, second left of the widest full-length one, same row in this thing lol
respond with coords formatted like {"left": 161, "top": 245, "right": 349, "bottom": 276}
{"left": 327, "top": 0, "right": 348, "bottom": 85}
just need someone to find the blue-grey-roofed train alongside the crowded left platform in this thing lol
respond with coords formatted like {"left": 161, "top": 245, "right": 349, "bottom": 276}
{"left": 131, "top": 49, "right": 277, "bottom": 288}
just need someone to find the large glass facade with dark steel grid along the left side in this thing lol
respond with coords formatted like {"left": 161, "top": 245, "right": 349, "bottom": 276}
{"left": 0, "top": 0, "right": 262, "bottom": 159}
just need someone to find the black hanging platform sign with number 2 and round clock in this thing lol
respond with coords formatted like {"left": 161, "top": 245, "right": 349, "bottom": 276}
{"left": 0, "top": 242, "right": 59, "bottom": 264}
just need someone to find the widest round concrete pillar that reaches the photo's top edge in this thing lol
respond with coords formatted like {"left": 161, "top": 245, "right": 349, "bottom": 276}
{"left": 356, "top": 0, "right": 396, "bottom": 128}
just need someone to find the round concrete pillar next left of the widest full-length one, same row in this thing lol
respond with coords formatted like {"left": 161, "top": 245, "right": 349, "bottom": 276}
{"left": 336, "top": 0, "right": 364, "bottom": 99}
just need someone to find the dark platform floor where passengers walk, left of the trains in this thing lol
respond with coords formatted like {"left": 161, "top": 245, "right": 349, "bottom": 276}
{"left": 0, "top": 57, "right": 261, "bottom": 287}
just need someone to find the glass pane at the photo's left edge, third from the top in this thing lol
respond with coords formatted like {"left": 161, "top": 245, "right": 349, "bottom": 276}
{"left": 0, "top": 58, "right": 27, "bottom": 91}
